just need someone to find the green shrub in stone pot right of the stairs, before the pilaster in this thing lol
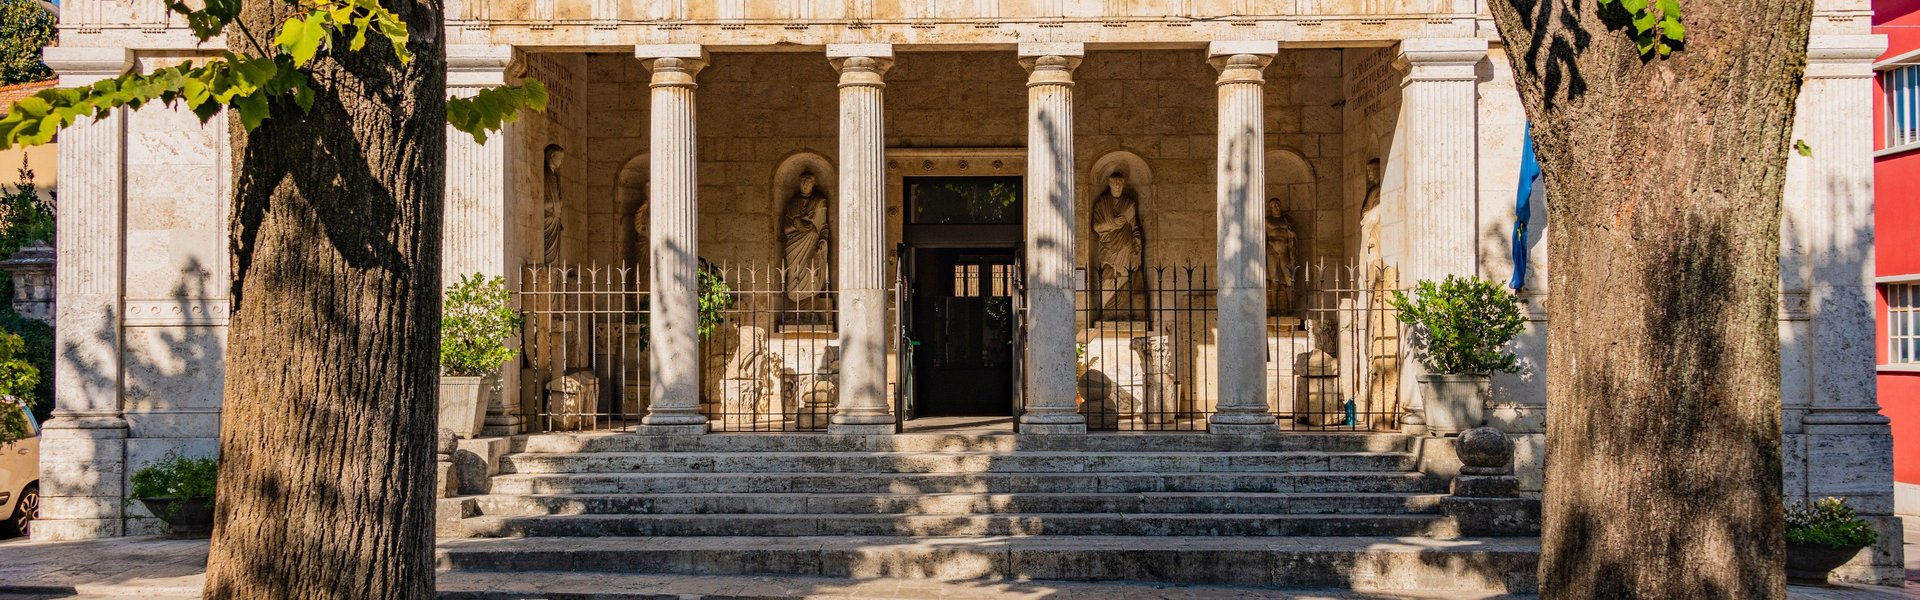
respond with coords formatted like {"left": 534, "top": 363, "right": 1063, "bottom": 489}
{"left": 1390, "top": 275, "right": 1526, "bottom": 435}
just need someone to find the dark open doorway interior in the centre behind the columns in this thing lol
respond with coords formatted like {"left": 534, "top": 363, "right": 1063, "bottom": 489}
{"left": 902, "top": 177, "right": 1021, "bottom": 419}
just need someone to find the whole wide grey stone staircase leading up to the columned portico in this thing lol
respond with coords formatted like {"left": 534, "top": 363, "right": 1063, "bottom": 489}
{"left": 440, "top": 433, "right": 1536, "bottom": 592}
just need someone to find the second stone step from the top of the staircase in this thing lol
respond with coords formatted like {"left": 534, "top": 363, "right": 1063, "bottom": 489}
{"left": 501, "top": 452, "right": 1417, "bottom": 473}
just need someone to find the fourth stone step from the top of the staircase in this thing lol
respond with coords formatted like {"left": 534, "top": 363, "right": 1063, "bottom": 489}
{"left": 474, "top": 492, "right": 1444, "bottom": 515}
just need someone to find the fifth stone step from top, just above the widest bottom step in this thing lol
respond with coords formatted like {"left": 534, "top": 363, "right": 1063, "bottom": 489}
{"left": 461, "top": 513, "right": 1457, "bottom": 538}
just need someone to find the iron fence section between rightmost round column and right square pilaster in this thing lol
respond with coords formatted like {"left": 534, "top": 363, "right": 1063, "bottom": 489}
{"left": 1267, "top": 263, "right": 1407, "bottom": 431}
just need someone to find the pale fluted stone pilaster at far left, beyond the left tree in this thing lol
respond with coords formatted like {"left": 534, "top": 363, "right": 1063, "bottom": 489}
{"left": 33, "top": 46, "right": 132, "bottom": 542}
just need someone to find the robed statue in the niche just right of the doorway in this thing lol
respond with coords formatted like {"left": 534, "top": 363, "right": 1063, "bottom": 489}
{"left": 1092, "top": 171, "right": 1146, "bottom": 321}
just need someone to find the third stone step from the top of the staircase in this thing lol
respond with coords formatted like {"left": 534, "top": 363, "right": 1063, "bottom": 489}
{"left": 488, "top": 471, "right": 1446, "bottom": 496}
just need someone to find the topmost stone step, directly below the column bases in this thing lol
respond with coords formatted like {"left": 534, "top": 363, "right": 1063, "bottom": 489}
{"left": 515, "top": 433, "right": 1409, "bottom": 454}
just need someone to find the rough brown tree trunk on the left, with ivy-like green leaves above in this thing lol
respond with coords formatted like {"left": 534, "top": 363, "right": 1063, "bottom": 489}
{"left": 205, "top": 0, "right": 447, "bottom": 598}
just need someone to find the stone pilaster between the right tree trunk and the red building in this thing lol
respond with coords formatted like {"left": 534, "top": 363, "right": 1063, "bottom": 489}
{"left": 1780, "top": 35, "right": 1905, "bottom": 585}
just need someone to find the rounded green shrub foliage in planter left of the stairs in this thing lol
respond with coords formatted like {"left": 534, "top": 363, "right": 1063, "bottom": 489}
{"left": 440, "top": 273, "right": 520, "bottom": 377}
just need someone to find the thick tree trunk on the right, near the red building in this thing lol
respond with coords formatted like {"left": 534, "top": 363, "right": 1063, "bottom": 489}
{"left": 1488, "top": 0, "right": 1812, "bottom": 598}
